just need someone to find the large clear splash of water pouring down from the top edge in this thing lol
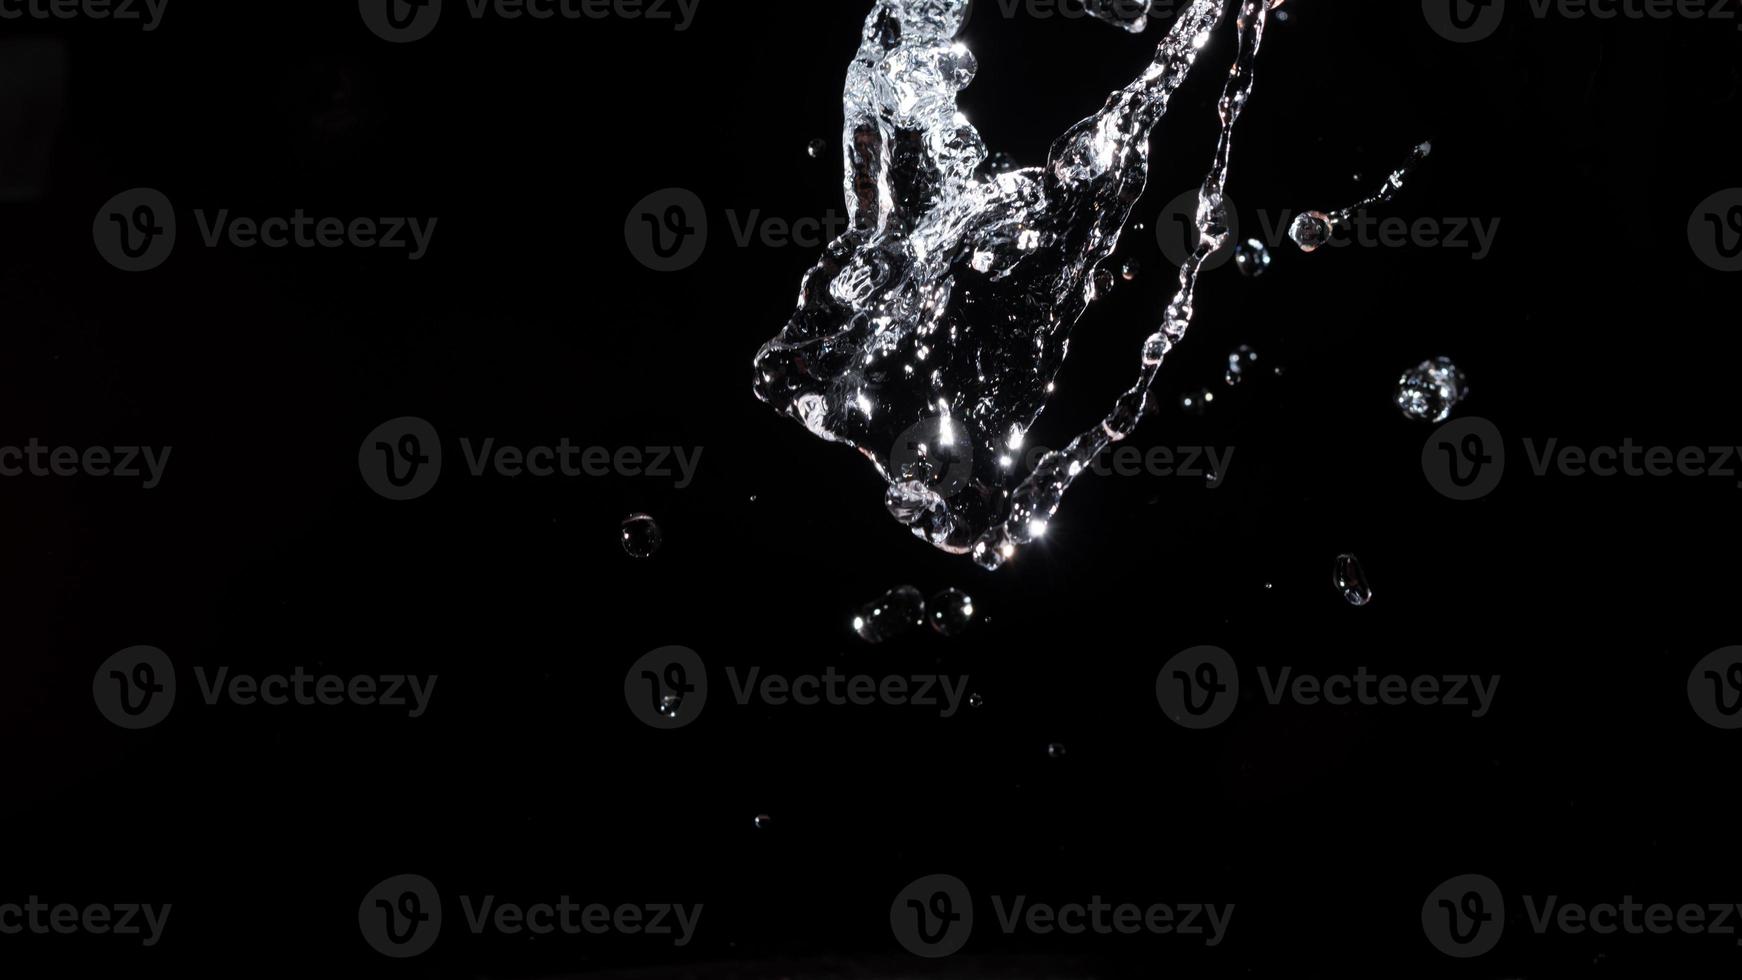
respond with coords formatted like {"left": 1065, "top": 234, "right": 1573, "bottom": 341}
{"left": 754, "top": 0, "right": 1280, "bottom": 569}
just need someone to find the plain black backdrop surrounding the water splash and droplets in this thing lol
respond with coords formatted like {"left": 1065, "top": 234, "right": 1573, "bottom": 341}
{"left": 0, "top": 0, "right": 1742, "bottom": 977}
